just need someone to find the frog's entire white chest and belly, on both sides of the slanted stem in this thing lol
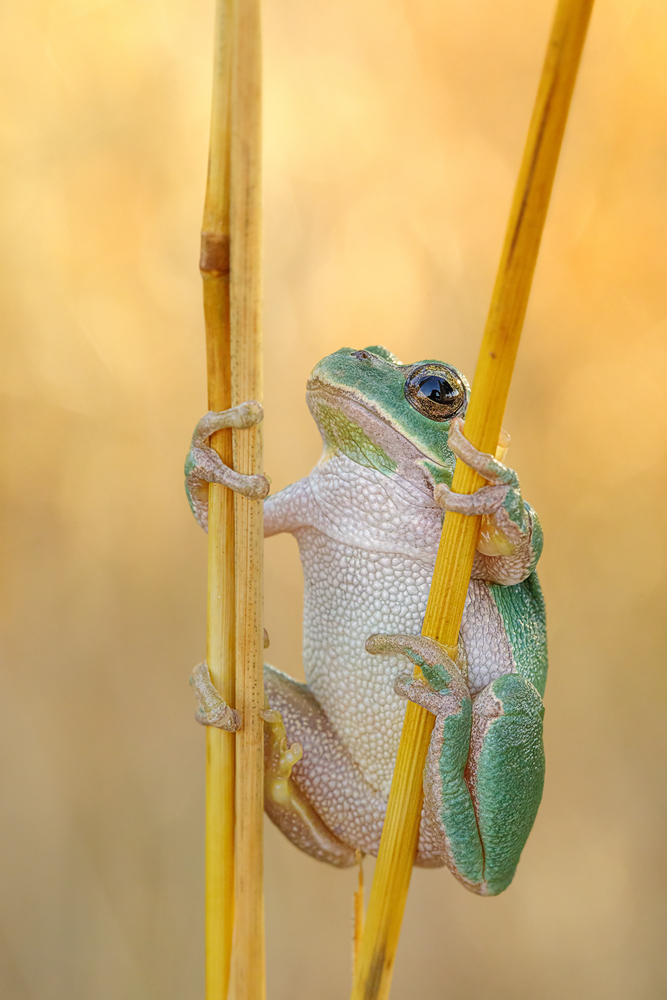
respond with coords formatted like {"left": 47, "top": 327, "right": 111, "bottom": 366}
{"left": 294, "top": 456, "right": 514, "bottom": 795}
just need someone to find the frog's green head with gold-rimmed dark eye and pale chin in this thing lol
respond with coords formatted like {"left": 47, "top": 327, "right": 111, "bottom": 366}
{"left": 307, "top": 346, "right": 470, "bottom": 485}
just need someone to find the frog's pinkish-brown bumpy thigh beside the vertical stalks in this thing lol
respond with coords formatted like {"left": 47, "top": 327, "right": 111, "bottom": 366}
{"left": 264, "top": 665, "right": 385, "bottom": 868}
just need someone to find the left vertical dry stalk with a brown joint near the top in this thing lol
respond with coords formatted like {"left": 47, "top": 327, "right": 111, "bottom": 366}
{"left": 200, "top": 0, "right": 236, "bottom": 1000}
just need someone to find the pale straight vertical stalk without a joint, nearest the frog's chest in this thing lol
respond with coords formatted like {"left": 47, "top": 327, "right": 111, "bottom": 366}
{"left": 230, "top": 0, "right": 266, "bottom": 1000}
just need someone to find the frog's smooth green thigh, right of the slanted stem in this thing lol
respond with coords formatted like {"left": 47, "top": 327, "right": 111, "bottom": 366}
{"left": 466, "top": 674, "right": 544, "bottom": 896}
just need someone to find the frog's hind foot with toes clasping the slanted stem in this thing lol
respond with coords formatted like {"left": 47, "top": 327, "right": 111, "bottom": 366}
{"left": 366, "top": 635, "right": 470, "bottom": 717}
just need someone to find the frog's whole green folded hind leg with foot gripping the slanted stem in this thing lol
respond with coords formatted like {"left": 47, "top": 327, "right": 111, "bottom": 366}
{"left": 366, "top": 635, "right": 544, "bottom": 896}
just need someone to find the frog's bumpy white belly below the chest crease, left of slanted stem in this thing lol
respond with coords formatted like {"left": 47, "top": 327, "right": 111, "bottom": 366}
{"left": 298, "top": 528, "right": 433, "bottom": 794}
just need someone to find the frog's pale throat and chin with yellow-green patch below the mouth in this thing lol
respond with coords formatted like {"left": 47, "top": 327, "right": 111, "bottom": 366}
{"left": 306, "top": 378, "right": 456, "bottom": 492}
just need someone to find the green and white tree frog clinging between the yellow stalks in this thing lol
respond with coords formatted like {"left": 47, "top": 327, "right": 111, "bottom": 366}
{"left": 186, "top": 345, "right": 547, "bottom": 896}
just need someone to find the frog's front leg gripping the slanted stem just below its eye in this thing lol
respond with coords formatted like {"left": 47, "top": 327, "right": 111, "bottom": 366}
{"left": 434, "top": 417, "right": 542, "bottom": 586}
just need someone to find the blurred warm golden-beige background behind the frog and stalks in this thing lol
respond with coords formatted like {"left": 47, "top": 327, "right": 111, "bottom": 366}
{"left": 0, "top": 0, "right": 667, "bottom": 1000}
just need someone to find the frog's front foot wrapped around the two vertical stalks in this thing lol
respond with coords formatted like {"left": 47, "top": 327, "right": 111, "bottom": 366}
{"left": 185, "top": 402, "right": 271, "bottom": 530}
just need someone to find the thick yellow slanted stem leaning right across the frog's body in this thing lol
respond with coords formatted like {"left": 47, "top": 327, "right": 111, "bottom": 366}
{"left": 352, "top": 0, "right": 593, "bottom": 1000}
